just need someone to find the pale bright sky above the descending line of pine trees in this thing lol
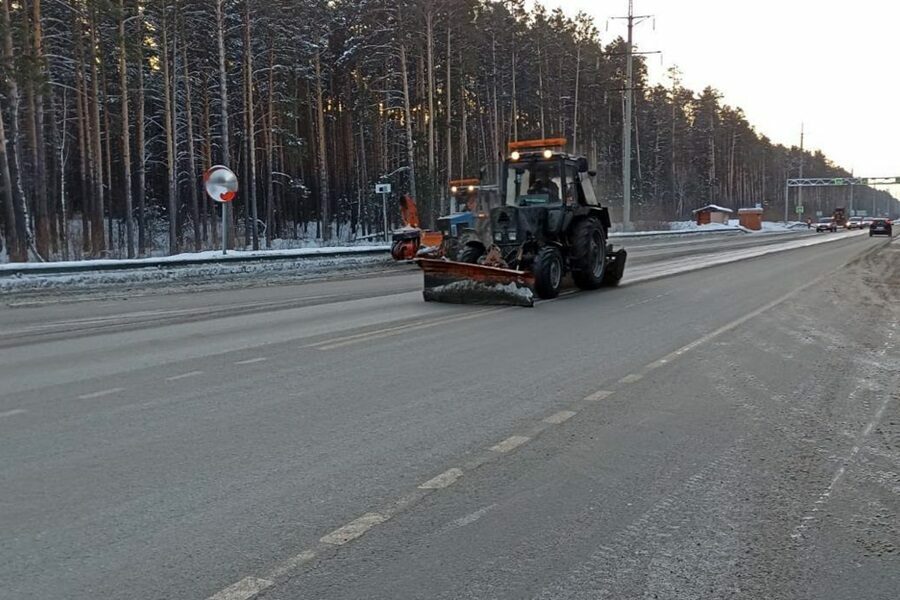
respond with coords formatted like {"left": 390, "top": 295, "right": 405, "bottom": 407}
{"left": 541, "top": 0, "right": 900, "bottom": 177}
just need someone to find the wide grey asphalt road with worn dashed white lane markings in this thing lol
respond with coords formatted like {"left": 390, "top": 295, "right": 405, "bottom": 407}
{"left": 0, "top": 234, "right": 900, "bottom": 600}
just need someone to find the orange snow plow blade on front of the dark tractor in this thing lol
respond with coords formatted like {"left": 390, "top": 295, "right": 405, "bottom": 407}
{"left": 416, "top": 258, "right": 534, "bottom": 306}
